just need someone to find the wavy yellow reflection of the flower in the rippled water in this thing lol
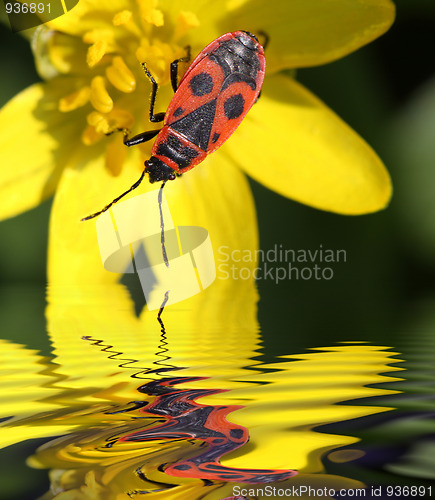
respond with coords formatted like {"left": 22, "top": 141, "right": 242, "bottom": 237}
{"left": 0, "top": 338, "right": 401, "bottom": 500}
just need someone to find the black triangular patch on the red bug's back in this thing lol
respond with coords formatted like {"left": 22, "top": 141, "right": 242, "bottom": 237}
{"left": 171, "top": 99, "right": 217, "bottom": 151}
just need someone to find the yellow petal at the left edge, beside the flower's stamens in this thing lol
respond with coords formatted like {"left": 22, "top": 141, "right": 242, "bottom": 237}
{"left": 0, "top": 80, "right": 81, "bottom": 218}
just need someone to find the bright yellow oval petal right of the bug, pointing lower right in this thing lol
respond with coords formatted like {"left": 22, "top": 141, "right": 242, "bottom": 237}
{"left": 224, "top": 75, "right": 391, "bottom": 215}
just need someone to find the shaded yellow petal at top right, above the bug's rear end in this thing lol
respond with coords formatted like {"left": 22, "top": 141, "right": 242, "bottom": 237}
{"left": 220, "top": 0, "right": 395, "bottom": 73}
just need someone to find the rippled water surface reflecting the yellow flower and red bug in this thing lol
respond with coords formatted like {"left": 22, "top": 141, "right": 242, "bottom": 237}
{"left": 0, "top": 288, "right": 435, "bottom": 500}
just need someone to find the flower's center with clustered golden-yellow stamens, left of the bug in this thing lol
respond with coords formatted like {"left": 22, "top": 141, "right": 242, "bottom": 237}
{"left": 50, "top": 0, "right": 199, "bottom": 175}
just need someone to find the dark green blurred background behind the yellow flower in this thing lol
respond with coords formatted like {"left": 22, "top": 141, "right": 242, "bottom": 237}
{"left": 0, "top": 0, "right": 435, "bottom": 355}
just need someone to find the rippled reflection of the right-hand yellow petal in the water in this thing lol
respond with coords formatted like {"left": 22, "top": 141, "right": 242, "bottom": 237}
{"left": 216, "top": 344, "right": 400, "bottom": 473}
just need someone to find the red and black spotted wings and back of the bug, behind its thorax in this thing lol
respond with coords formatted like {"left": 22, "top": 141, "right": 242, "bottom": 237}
{"left": 164, "top": 32, "right": 265, "bottom": 163}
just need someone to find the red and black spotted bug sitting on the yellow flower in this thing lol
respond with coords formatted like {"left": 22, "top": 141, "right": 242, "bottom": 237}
{"left": 82, "top": 31, "right": 266, "bottom": 220}
